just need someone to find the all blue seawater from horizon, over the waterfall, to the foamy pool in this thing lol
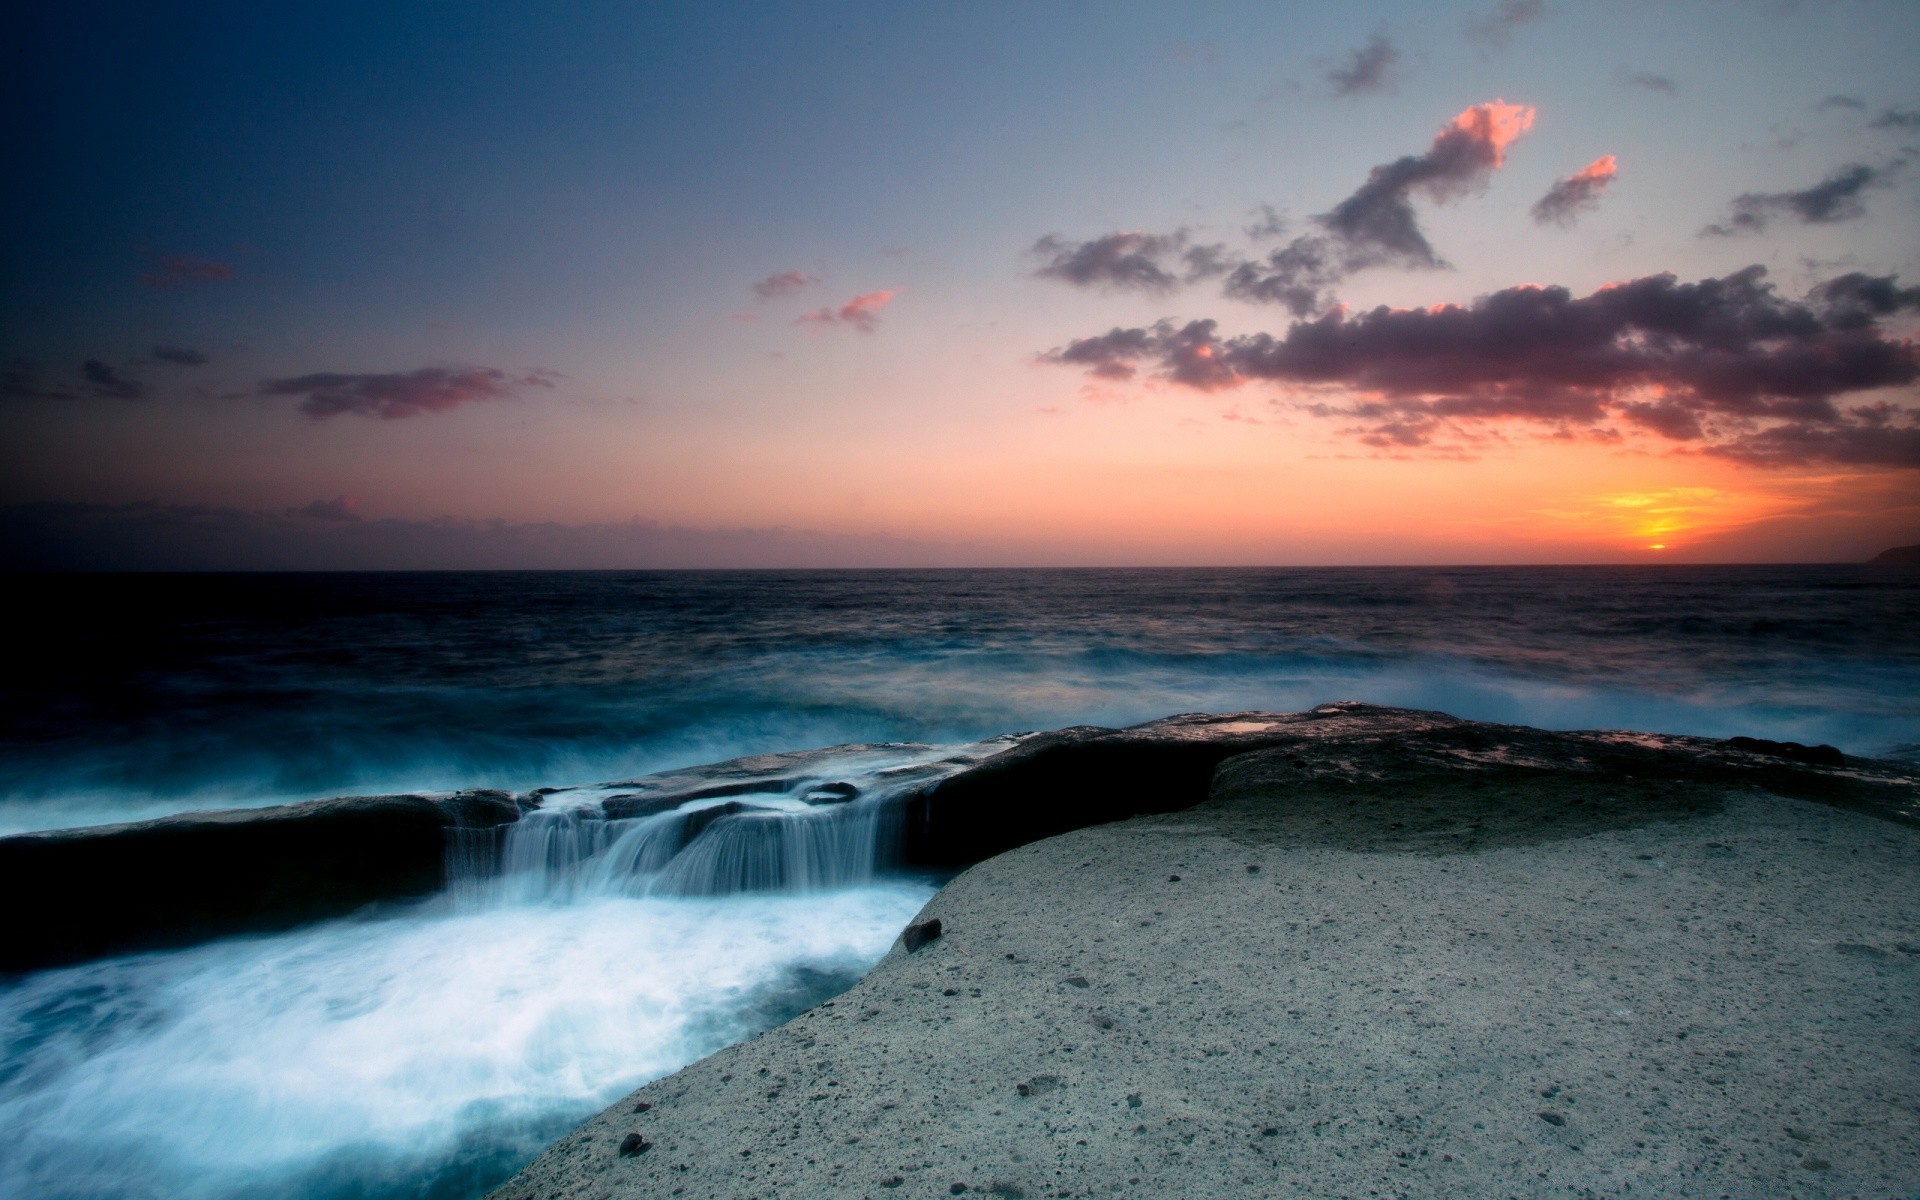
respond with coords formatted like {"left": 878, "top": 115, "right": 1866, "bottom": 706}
{"left": 0, "top": 566, "right": 1920, "bottom": 1200}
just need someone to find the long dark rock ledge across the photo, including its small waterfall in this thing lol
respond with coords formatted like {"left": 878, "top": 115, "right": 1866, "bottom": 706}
{"left": 0, "top": 703, "right": 1912, "bottom": 972}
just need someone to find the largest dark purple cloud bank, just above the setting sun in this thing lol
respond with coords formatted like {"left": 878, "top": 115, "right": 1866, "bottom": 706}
{"left": 1043, "top": 267, "right": 1920, "bottom": 468}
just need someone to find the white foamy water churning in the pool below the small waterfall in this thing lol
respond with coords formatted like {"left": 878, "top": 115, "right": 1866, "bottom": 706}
{"left": 0, "top": 881, "right": 931, "bottom": 1196}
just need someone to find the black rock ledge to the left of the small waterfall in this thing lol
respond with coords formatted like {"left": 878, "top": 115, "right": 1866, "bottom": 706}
{"left": 0, "top": 791, "right": 520, "bottom": 972}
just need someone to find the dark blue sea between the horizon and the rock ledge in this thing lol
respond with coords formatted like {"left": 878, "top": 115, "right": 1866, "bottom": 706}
{"left": 0, "top": 566, "right": 1920, "bottom": 831}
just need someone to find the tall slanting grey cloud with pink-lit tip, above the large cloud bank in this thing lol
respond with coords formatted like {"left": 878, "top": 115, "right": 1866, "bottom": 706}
{"left": 1225, "top": 100, "right": 1534, "bottom": 315}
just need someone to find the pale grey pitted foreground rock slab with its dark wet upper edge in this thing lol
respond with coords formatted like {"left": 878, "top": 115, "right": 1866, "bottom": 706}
{"left": 493, "top": 705, "right": 1920, "bottom": 1200}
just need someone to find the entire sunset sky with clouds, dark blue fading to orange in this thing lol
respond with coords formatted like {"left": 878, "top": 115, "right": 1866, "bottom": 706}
{"left": 0, "top": 0, "right": 1920, "bottom": 568}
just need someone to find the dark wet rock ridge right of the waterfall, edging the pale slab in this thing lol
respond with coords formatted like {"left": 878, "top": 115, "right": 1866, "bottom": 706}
{"left": 902, "top": 703, "right": 1916, "bottom": 868}
